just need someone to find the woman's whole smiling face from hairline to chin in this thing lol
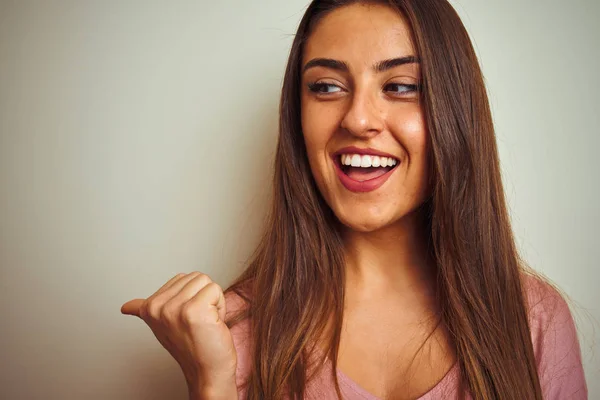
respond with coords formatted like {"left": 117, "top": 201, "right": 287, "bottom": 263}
{"left": 301, "top": 4, "right": 428, "bottom": 232}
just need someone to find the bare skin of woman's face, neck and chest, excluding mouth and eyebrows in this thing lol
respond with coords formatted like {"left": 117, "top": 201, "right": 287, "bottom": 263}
{"left": 301, "top": 4, "right": 455, "bottom": 399}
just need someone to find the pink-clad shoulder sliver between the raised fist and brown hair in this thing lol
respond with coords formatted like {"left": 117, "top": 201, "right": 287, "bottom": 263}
{"left": 225, "top": 291, "right": 252, "bottom": 399}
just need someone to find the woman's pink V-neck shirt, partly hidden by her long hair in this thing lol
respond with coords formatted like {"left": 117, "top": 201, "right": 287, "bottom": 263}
{"left": 226, "top": 277, "right": 587, "bottom": 400}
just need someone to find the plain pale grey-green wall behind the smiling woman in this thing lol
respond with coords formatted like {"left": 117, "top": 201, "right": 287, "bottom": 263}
{"left": 0, "top": 0, "right": 600, "bottom": 400}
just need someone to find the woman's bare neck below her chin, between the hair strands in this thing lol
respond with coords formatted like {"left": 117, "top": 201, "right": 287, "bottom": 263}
{"left": 344, "top": 213, "right": 435, "bottom": 298}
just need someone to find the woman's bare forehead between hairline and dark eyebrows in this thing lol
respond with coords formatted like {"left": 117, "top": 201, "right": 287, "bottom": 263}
{"left": 303, "top": 3, "right": 416, "bottom": 67}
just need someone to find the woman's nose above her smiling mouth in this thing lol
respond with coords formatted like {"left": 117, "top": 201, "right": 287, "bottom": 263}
{"left": 341, "top": 87, "right": 384, "bottom": 139}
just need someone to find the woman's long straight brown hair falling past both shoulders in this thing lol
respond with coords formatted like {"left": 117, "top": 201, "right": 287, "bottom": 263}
{"left": 226, "top": 0, "right": 542, "bottom": 400}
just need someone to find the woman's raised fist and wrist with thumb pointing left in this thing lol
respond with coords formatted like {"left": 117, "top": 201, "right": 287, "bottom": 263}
{"left": 121, "top": 272, "right": 237, "bottom": 400}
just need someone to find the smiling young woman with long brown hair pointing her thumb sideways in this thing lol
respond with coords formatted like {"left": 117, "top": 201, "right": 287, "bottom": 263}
{"left": 122, "top": 0, "right": 587, "bottom": 400}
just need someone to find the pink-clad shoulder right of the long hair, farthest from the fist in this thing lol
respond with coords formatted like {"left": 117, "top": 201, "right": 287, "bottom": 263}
{"left": 523, "top": 275, "right": 587, "bottom": 399}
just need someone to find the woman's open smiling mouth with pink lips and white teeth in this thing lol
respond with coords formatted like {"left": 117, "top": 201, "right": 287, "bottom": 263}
{"left": 335, "top": 154, "right": 399, "bottom": 182}
